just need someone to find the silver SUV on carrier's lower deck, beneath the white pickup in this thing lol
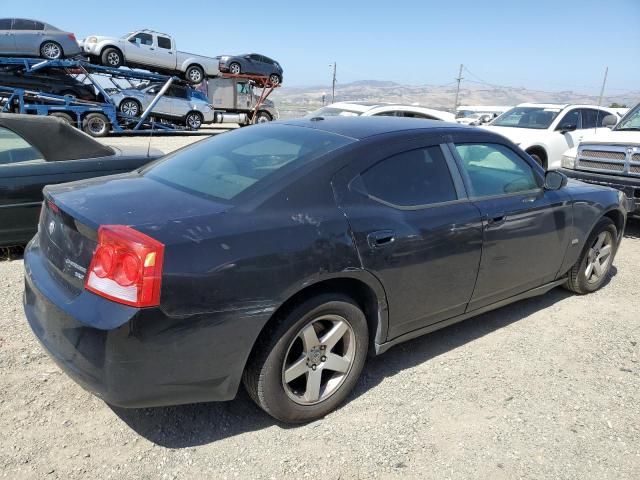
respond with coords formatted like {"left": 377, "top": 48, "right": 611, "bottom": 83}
{"left": 108, "top": 83, "right": 214, "bottom": 130}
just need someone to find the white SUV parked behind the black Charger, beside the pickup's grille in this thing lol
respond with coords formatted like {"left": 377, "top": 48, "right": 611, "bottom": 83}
{"left": 482, "top": 103, "right": 619, "bottom": 169}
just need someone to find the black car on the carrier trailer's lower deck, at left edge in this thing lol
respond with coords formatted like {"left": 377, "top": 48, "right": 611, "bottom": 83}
{"left": 0, "top": 68, "right": 102, "bottom": 101}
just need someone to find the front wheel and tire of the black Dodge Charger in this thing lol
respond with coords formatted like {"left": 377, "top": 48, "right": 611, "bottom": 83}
{"left": 564, "top": 217, "right": 618, "bottom": 295}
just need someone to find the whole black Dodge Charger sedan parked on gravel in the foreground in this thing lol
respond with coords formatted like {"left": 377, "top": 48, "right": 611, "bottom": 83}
{"left": 24, "top": 117, "right": 626, "bottom": 423}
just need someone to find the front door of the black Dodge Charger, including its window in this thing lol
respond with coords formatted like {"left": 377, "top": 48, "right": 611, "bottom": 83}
{"left": 450, "top": 140, "right": 571, "bottom": 311}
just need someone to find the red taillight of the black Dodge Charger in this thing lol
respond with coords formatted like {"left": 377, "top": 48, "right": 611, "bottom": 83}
{"left": 85, "top": 225, "right": 164, "bottom": 307}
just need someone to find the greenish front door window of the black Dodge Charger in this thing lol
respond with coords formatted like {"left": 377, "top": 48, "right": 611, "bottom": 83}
{"left": 456, "top": 143, "right": 539, "bottom": 197}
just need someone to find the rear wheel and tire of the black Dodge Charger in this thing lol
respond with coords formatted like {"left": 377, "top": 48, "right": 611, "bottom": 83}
{"left": 243, "top": 294, "right": 369, "bottom": 423}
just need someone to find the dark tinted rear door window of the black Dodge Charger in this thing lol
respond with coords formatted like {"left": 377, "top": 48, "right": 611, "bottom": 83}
{"left": 360, "top": 146, "right": 458, "bottom": 207}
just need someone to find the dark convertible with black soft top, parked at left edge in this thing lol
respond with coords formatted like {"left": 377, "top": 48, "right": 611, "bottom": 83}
{"left": 0, "top": 114, "right": 161, "bottom": 246}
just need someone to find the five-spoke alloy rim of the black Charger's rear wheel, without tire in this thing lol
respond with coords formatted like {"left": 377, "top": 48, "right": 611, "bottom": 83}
{"left": 282, "top": 315, "right": 356, "bottom": 405}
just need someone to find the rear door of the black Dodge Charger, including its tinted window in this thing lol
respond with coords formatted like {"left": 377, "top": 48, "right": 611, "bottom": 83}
{"left": 334, "top": 134, "right": 482, "bottom": 339}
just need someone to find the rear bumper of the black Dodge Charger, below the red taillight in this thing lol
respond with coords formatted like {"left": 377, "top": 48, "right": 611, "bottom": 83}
{"left": 24, "top": 238, "right": 266, "bottom": 407}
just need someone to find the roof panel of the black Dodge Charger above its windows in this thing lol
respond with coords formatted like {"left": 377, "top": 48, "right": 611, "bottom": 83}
{"left": 273, "top": 116, "right": 475, "bottom": 140}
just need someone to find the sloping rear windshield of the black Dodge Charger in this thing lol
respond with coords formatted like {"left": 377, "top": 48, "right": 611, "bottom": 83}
{"left": 144, "top": 125, "right": 355, "bottom": 200}
